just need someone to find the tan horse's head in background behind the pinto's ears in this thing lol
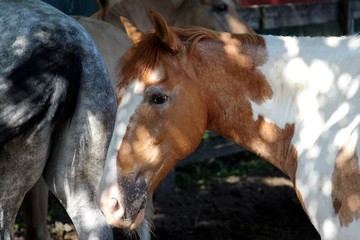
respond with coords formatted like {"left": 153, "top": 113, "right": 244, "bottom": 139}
{"left": 92, "top": 0, "right": 254, "bottom": 33}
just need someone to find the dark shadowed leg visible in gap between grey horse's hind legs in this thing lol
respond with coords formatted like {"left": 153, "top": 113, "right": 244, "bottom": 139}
{"left": 21, "top": 177, "right": 51, "bottom": 240}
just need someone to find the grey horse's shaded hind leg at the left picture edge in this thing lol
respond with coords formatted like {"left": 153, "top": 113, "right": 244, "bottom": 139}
{"left": 0, "top": 125, "right": 51, "bottom": 240}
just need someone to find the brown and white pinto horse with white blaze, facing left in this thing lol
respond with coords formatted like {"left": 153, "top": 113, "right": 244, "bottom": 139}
{"left": 98, "top": 12, "right": 360, "bottom": 240}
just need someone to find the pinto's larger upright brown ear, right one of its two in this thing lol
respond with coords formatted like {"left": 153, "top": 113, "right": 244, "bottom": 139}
{"left": 150, "top": 10, "right": 181, "bottom": 54}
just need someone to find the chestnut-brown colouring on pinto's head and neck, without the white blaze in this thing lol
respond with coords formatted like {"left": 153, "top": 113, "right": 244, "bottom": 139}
{"left": 97, "top": 12, "right": 297, "bottom": 232}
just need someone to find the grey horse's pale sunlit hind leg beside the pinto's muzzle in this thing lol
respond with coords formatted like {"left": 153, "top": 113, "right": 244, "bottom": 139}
{"left": 43, "top": 68, "right": 116, "bottom": 240}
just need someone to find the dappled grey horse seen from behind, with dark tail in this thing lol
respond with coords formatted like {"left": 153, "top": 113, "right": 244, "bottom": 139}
{"left": 0, "top": 0, "right": 116, "bottom": 239}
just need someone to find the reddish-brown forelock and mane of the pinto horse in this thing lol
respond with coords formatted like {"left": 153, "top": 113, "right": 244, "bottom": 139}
{"left": 118, "top": 27, "right": 265, "bottom": 91}
